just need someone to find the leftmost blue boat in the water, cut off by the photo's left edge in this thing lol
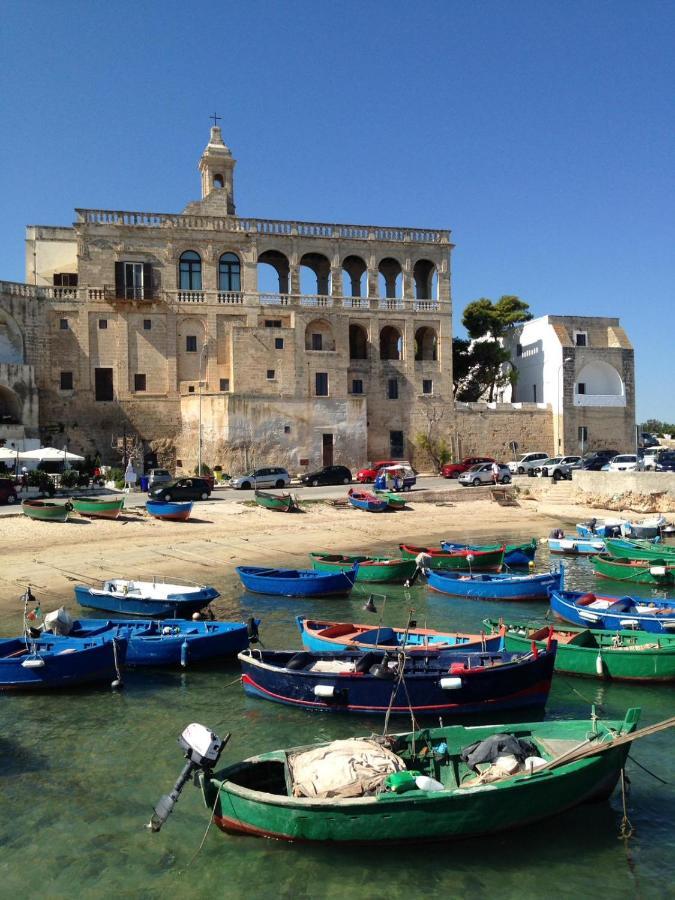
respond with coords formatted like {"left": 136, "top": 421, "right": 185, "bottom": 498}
{"left": 0, "top": 636, "right": 127, "bottom": 690}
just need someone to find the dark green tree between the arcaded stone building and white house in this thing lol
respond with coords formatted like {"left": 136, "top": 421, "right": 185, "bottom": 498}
{"left": 452, "top": 294, "right": 532, "bottom": 403}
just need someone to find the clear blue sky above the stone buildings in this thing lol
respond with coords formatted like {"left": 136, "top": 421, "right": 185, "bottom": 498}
{"left": 0, "top": 0, "right": 675, "bottom": 422}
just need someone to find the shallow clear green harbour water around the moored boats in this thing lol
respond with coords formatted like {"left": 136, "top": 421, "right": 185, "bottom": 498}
{"left": 0, "top": 536, "right": 675, "bottom": 900}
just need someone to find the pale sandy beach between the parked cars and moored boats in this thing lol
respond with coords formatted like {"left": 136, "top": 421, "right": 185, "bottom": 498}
{"left": 0, "top": 499, "right": 600, "bottom": 633}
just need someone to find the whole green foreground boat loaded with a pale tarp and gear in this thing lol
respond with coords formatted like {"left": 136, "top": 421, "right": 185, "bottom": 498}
{"left": 198, "top": 709, "right": 640, "bottom": 843}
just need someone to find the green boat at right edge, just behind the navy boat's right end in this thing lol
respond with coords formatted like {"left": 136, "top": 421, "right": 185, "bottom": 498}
{"left": 483, "top": 619, "right": 675, "bottom": 683}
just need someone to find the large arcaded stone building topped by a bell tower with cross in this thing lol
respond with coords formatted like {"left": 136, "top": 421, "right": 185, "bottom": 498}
{"left": 0, "top": 127, "right": 452, "bottom": 471}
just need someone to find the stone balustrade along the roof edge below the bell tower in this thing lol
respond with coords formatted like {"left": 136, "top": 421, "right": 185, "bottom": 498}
{"left": 75, "top": 209, "right": 450, "bottom": 244}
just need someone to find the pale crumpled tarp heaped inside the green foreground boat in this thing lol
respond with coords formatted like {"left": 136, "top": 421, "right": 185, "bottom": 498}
{"left": 288, "top": 738, "right": 406, "bottom": 798}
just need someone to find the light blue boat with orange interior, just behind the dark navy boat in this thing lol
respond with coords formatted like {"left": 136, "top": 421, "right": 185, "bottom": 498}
{"left": 295, "top": 616, "right": 500, "bottom": 654}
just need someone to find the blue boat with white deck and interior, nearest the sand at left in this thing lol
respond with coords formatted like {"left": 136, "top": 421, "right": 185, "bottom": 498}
{"left": 75, "top": 578, "right": 220, "bottom": 619}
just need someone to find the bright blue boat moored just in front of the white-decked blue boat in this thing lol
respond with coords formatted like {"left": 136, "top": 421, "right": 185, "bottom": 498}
{"left": 52, "top": 619, "right": 258, "bottom": 667}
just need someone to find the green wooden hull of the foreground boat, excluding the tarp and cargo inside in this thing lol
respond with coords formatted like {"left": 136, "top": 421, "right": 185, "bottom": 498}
{"left": 201, "top": 711, "right": 635, "bottom": 844}
